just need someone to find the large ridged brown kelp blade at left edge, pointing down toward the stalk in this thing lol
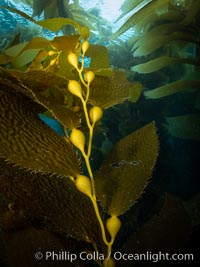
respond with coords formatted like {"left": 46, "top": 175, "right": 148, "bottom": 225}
{"left": 0, "top": 86, "right": 80, "bottom": 176}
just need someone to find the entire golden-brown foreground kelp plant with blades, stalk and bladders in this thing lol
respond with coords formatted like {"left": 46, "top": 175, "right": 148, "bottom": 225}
{"left": 0, "top": 7, "right": 159, "bottom": 266}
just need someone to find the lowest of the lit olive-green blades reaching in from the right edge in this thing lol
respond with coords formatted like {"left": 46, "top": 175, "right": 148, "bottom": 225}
{"left": 144, "top": 80, "right": 200, "bottom": 99}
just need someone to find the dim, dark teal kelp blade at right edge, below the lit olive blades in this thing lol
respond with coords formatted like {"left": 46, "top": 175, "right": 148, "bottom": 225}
{"left": 165, "top": 114, "right": 200, "bottom": 140}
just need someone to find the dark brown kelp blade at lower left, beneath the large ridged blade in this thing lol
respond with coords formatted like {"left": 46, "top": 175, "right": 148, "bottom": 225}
{"left": 0, "top": 158, "right": 101, "bottom": 246}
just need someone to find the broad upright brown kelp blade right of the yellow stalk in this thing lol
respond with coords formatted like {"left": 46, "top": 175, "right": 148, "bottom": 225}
{"left": 95, "top": 123, "right": 159, "bottom": 215}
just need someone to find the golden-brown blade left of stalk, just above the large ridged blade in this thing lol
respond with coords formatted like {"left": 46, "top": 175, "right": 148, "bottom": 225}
{"left": 8, "top": 70, "right": 80, "bottom": 129}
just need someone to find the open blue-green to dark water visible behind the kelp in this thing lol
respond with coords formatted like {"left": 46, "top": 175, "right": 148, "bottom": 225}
{"left": 0, "top": 0, "right": 200, "bottom": 267}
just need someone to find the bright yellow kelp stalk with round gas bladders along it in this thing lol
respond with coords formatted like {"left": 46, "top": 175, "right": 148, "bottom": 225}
{"left": 68, "top": 40, "right": 121, "bottom": 266}
